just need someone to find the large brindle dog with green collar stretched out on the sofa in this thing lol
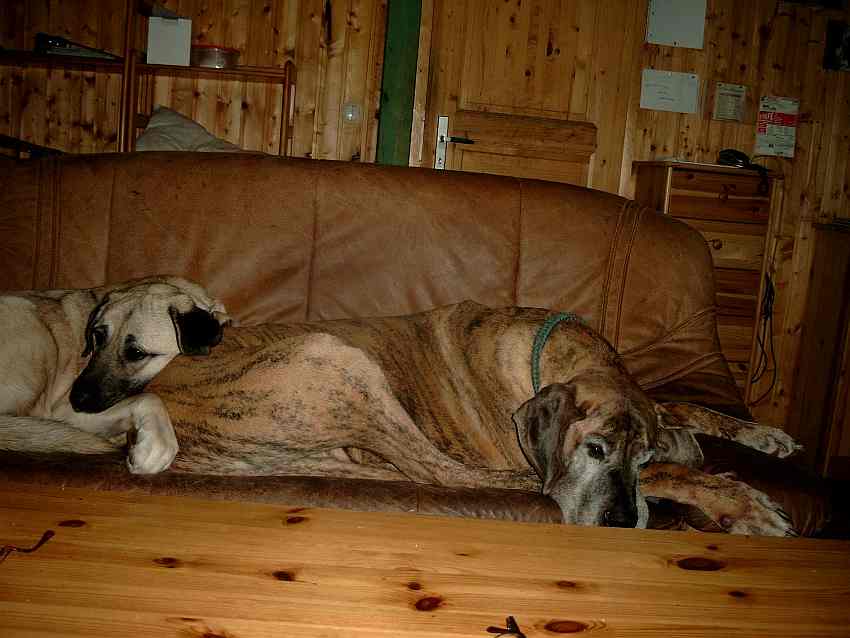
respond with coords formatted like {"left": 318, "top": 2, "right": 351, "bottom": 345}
{"left": 151, "top": 302, "right": 797, "bottom": 535}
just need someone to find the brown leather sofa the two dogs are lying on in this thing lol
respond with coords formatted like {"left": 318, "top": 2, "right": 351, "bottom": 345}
{"left": 0, "top": 153, "right": 832, "bottom": 533}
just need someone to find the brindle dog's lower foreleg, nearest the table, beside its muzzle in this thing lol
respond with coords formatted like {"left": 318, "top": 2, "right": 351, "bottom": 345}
{"left": 640, "top": 463, "right": 797, "bottom": 536}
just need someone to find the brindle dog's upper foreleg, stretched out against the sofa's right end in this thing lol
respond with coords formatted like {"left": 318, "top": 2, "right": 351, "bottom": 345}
{"left": 659, "top": 403, "right": 803, "bottom": 458}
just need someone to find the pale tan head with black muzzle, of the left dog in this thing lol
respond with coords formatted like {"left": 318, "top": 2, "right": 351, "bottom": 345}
{"left": 69, "top": 277, "right": 230, "bottom": 413}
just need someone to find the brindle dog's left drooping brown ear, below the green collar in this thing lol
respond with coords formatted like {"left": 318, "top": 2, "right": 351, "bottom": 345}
{"left": 513, "top": 383, "right": 585, "bottom": 494}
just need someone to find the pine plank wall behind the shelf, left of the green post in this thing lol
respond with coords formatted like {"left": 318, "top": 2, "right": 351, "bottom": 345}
{"left": 0, "top": 0, "right": 387, "bottom": 161}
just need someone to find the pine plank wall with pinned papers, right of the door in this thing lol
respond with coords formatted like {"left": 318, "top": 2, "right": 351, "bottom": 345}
{"left": 604, "top": 0, "right": 850, "bottom": 425}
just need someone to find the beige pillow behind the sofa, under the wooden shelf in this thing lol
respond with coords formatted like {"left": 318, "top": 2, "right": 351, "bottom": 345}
{"left": 136, "top": 106, "right": 242, "bottom": 152}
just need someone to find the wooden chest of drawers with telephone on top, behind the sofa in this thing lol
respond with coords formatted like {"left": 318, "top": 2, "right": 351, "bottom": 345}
{"left": 634, "top": 162, "right": 783, "bottom": 403}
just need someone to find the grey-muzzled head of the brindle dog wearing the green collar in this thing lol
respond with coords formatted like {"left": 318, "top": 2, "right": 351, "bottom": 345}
{"left": 513, "top": 383, "right": 657, "bottom": 527}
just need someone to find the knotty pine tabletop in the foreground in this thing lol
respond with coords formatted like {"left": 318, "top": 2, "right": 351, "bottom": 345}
{"left": 0, "top": 483, "right": 850, "bottom": 638}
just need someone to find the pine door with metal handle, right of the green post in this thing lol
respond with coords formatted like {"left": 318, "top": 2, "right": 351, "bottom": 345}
{"left": 421, "top": 0, "right": 596, "bottom": 185}
